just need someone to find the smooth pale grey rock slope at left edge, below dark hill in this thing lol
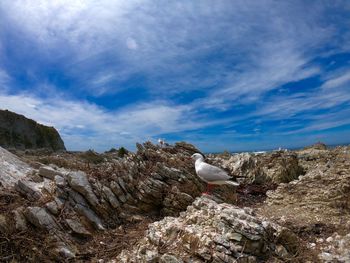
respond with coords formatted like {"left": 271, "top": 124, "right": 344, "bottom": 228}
{"left": 0, "top": 147, "right": 33, "bottom": 188}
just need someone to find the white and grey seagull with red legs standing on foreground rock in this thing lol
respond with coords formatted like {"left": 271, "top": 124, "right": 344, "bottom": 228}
{"left": 191, "top": 153, "right": 239, "bottom": 194}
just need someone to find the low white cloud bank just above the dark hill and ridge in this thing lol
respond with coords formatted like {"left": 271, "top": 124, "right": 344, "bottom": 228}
{"left": 0, "top": 93, "right": 216, "bottom": 150}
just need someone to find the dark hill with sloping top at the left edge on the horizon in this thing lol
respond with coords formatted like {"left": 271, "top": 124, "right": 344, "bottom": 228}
{"left": 0, "top": 110, "right": 66, "bottom": 151}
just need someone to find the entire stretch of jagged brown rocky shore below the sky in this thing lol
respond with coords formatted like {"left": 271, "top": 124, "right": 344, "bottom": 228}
{"left": 0, "top": 142, "right": 349, "bottom": 262}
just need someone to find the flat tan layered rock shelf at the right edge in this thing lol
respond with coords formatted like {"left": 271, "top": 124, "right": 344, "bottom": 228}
{"left": 261, "top": 148, "right": 350, "bottom": 231}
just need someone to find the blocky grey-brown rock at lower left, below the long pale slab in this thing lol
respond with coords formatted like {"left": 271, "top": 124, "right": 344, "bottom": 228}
{"left": 25, "top": 207, "right": 58, "bottom": 230}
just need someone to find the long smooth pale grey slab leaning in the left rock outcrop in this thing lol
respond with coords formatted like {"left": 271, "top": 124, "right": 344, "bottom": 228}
{"left": 67, "top": 171, "right": 99, "bottom": 207}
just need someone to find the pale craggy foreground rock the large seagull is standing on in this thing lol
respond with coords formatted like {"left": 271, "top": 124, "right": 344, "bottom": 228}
{"left": 117, "top": 197, "right": 298, "bottom": 262}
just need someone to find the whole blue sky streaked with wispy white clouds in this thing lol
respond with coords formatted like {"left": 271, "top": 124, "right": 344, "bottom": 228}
{"left": 0, "top": 0, "right": 350, "bottom": 152}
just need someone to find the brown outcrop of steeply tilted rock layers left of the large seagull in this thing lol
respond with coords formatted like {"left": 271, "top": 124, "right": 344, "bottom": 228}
{"left": 3, "top": 142, "right": 211, "bottom": 262}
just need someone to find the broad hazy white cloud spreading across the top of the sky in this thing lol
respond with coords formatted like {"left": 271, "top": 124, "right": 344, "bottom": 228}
{"left": 0, "top": 0, "right": 332, "bottom": 100}
